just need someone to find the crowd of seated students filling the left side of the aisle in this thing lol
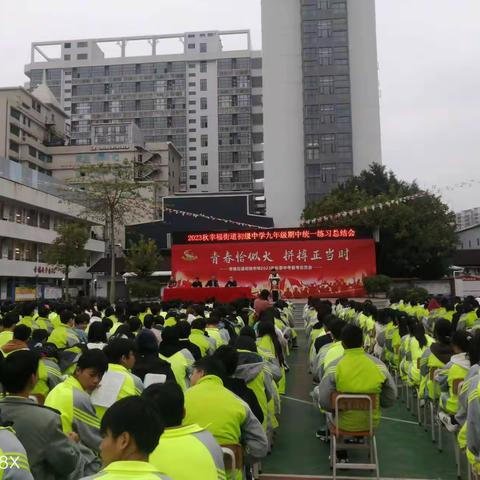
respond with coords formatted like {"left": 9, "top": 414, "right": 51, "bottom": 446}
{"left": 0, "top": 292, "right": 296, "bottom": 480}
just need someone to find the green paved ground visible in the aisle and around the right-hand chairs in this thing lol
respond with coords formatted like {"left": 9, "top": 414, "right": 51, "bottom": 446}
{"left": 261, "top": 306, "right": 465, "bottom": 480}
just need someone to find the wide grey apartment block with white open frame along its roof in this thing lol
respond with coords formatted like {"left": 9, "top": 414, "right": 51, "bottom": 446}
{"left": 25, "top": 31, "right": 264, "bottom": 205}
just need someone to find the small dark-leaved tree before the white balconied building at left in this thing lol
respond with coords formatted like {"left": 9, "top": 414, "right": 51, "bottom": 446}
{"left": 45, "top": 223, "right": 90, "bottom": 301}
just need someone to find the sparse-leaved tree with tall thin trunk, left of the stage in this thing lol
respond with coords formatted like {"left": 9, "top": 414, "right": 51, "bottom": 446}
{"left": 69, "top": 160, "right": 156, "bottom": 303}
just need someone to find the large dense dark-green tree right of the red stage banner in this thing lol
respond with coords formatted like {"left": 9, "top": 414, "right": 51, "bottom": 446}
{"left": 303, "top": 164, "right": 456, "bottom": 278}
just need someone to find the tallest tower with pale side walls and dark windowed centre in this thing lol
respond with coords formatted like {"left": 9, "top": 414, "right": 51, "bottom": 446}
{"left": 262, "top": 0, "right": 381, "bottom": 226}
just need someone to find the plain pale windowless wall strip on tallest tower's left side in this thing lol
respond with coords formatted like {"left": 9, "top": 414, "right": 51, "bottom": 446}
{"left": 262, "top": 0, "right": 305, "bottom": 227}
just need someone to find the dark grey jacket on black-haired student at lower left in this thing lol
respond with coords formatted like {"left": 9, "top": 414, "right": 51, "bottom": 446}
{"left": 0, "top": 396, "right": 81, "bottom": 480}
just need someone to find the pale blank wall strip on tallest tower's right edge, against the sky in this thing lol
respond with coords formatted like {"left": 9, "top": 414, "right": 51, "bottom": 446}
{"left": 348, "top": 0, "right": 382, "bottom": 175}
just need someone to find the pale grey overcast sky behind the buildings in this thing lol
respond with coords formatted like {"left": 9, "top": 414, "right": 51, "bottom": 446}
{"left": 0, "top": 0, "right": 480, "bottom": 210}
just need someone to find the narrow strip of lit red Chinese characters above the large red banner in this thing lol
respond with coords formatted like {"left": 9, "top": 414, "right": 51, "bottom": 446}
{"left": 187, "top": 228, "right": 357, "bottom": 243}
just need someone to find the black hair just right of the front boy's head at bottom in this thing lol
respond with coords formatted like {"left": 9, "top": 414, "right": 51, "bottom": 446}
{"left": 142, "top": 381, "right": 185, "bottom": 428}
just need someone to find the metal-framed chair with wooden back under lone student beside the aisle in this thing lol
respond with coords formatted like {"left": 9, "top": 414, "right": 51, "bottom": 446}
{"left": 329, "top": 392, "right": 380, "bottom": 480}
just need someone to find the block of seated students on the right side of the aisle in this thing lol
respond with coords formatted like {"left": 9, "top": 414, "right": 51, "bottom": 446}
{"left": 303, "top": 296, "right": 480, "bottom": 475}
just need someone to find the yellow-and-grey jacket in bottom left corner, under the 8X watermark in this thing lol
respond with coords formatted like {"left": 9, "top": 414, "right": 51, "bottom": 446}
{"left": 0, "top": 428, "right": 33, "bottom": 480}
